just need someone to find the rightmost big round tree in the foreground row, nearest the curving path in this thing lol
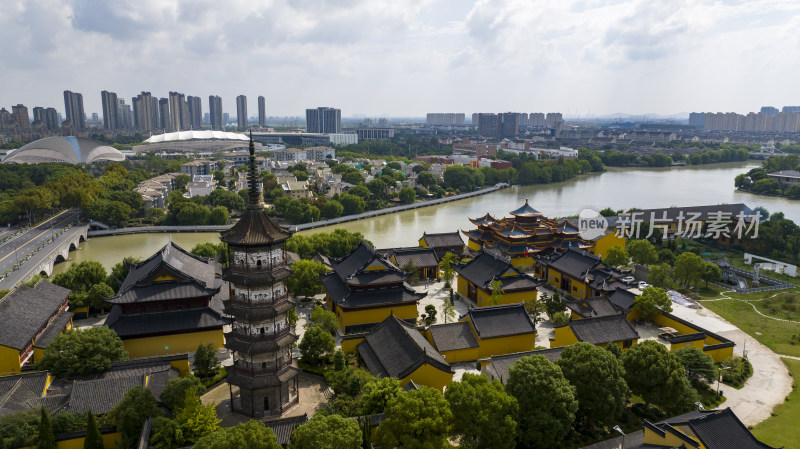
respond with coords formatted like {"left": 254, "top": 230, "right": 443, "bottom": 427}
{"left": 622, "top": 340, "right": 696, "bottom": 413}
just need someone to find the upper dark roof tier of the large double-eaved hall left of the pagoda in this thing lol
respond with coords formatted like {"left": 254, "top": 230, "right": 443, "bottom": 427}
{"left": 118, "top": 241, "right": 219, "bottom": 297}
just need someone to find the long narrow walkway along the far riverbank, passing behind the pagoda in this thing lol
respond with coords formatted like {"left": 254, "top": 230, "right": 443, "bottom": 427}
{"left": 89, "top": 183, "right": 509, "bottom": 237}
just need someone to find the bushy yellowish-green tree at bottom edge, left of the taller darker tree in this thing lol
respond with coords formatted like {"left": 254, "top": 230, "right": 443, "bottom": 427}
{"left": 444, "top": 373, "right": 519, "bottom": 449}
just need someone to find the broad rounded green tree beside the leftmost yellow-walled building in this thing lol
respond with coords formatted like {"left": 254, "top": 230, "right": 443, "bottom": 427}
{"left": 36, "top": 326, "right": 128, "bottom": 378}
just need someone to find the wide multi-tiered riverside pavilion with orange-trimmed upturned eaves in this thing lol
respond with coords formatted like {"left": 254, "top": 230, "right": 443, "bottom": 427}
{"left": 462, "top": 200, "right": 591, "bottom": 266}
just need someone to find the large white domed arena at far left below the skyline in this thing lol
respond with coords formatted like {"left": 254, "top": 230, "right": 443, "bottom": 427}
{"left": 3, "top": 136, "right": 125, "bottom": 164}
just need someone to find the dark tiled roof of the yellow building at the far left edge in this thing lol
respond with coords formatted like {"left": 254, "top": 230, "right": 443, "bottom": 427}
{"left": 0, "top": 280, "right": 71, "bottom": 351}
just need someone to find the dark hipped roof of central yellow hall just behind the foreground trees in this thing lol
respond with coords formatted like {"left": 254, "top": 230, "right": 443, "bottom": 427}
{"left": 356, "top": 314, "right": 453, "bottom": 379}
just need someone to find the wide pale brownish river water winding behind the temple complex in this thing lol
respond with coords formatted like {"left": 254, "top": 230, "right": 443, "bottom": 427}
{"left": 55, "top": 161, "right": 800, "bottom": 273}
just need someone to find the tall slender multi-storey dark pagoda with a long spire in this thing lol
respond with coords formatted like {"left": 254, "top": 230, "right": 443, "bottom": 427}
{"left": 220, "top": 133, "right": 300, "bottom": 418}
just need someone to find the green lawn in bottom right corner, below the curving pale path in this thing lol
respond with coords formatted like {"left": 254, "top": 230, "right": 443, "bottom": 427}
{"left": 753, "top": 359, "right": 800, "bottom": 448}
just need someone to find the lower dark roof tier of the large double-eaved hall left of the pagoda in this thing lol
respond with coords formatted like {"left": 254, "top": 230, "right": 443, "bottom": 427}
{"left": 106, "top": 306, "right": 230, "bottom": 339}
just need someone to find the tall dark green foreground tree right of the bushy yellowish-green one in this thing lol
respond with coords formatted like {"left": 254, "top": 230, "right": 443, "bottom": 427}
{"left": 506, "top": 355, "right": 578, "bottom": 447}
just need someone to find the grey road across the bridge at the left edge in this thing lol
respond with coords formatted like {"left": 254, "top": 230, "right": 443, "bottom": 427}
{"left": 0, "top": 210, "right": 78, "bottom": 289}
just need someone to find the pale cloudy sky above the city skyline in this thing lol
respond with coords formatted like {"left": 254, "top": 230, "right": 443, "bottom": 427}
{"left": 0, "top": 0, "right": 800, "bottom": 117}
